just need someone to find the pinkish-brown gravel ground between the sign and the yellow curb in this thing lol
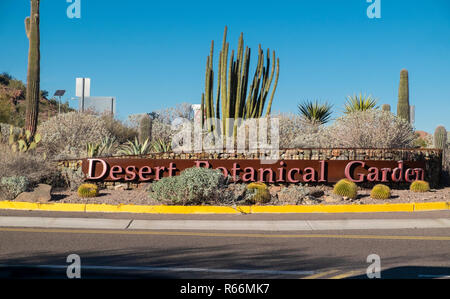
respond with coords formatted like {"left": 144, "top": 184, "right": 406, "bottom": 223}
{"left": 46, "top": 186, "right": 450, "bottom": 205}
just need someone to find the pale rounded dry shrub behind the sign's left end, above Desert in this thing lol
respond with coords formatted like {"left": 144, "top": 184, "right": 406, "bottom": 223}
{"left": 38, "top": 112, "right": 111, "bottom": 159}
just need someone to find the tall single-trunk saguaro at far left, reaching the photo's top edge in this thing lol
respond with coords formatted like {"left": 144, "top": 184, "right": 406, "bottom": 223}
{"left": 25, "top": 0, "right": 40, "bottom": 135}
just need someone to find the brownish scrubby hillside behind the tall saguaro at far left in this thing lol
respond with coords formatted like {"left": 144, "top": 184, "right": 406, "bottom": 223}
{"left": 0, "top": 73, "right": 74, "bottom": 127}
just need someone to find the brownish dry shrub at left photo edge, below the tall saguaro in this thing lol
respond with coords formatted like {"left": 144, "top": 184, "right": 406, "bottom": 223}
{"left": 0, "top": 144, "right": 61, "bottom": 187}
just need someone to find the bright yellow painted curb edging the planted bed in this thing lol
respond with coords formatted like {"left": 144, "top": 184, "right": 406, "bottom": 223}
{"left": 0, "top": 201, "right": 450, "bottom": 214}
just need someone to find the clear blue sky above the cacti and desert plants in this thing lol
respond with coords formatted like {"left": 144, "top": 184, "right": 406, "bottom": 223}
{"left": 0, "top": 0, "right": 450, "bottom": 132}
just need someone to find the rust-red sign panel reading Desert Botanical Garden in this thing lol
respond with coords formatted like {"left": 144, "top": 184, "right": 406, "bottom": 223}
{"left": 82, "top": 158, "right": 425, "bottom": 183}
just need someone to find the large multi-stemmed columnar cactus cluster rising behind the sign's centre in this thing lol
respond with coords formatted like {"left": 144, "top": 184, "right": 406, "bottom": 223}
{"left": 202, "top": 27, "right": 280, "bottom": 136}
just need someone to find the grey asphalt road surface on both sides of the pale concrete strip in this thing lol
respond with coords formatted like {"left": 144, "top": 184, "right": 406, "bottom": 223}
{"left": 0, "top": 211, "right": 450, "bottom": 279}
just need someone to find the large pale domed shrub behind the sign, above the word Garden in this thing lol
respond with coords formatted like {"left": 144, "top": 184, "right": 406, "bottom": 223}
{"left": 326, "top": 109, "right": 415, "bottom": 148}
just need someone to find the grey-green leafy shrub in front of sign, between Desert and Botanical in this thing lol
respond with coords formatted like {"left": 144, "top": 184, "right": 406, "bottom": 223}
{"left": 150, "top": 167, "right": 226, "bottom": 205}
